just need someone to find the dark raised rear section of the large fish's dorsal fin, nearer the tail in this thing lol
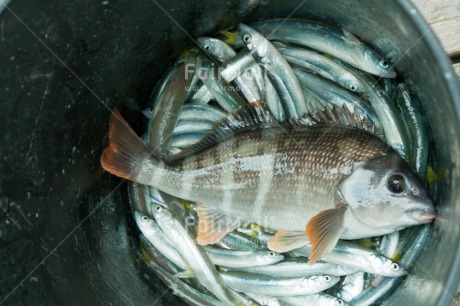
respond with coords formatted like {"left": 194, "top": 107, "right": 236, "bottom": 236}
{"left": 164, "top": 101, "right": 278, "bottom": 163}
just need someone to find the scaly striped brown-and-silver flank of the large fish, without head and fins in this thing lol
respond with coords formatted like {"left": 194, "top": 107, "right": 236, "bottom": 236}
{"left": 135, "top": 125, "right": 387, "bottom": 230}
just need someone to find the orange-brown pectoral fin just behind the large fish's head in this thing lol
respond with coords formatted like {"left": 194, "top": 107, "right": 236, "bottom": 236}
{"left": 307, "top": 207, "right": 347, "bottom": 265}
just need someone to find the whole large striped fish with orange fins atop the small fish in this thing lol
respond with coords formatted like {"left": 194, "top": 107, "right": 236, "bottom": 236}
{"left": 101, "top": 103, "right": 435, "bottom": 264}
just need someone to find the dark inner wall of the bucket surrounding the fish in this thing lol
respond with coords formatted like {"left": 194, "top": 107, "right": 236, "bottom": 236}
{"left": 0, "top": 0, "right": 460, "bottom": 305}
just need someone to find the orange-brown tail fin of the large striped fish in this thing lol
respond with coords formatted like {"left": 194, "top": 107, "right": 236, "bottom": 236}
{"left": 101, "top": 110, "right": 150, "bottom": 180}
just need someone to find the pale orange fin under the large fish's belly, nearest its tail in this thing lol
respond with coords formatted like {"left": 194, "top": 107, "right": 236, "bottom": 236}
{"left": 196, "top": 205, "right": 244, "bottom": 245}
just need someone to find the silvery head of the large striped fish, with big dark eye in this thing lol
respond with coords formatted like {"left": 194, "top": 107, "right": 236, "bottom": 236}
{"left": 338, "top": 151, "right": 435, "bottom": 233}
